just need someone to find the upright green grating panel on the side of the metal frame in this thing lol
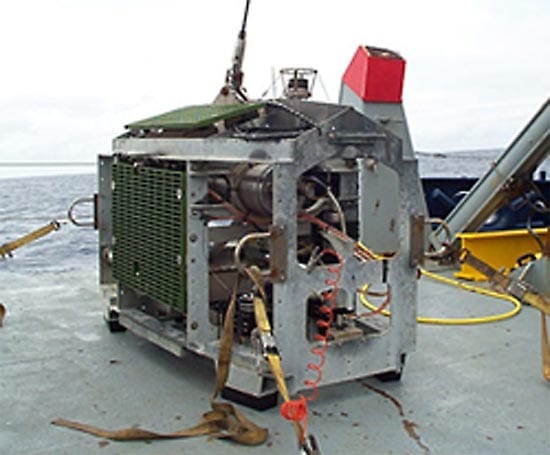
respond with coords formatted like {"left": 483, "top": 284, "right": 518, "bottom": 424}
{"left": 112, "top": 163, "right": 186, "bottom": 311}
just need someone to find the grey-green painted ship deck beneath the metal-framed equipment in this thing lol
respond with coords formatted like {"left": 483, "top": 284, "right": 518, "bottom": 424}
{"left": 0, "top": 271, "right": 550, "bottom": 455}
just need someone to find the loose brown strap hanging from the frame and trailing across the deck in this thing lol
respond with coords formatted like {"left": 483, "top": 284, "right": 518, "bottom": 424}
{"left": 52, "top": 280, "right": 268, "bottom": 445}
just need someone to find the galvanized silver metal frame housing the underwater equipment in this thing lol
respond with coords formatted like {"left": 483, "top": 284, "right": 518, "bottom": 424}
{"left": 100, "top": 103, "right": 423, "bottom": 396}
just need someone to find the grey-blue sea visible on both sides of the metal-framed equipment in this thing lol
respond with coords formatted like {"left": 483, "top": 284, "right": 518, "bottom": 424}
{"left": 0, "top": 150, "right": 550, "bottom": 276}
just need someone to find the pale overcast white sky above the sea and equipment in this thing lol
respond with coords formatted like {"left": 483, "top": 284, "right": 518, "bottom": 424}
{"left": 0, "top": 0, "right": 550, "bottom": 172}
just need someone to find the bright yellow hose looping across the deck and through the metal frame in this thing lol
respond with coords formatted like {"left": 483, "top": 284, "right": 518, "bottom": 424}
{"left": 360, "top": 269, "right": 521, "bottom": 325}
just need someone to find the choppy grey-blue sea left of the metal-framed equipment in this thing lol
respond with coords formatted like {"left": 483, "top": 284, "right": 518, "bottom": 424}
{"left": 0, "top": 174, "right": 97, "bottom": 276}
